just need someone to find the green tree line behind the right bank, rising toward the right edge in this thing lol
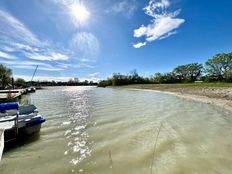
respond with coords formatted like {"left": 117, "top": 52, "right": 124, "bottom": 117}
{"left": 98, "top": 53, "right": 232, "bottom": 87}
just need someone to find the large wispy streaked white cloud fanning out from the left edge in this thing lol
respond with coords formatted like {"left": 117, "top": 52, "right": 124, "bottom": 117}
{"left": 0, "top": 10, "right": 69, "bottom": 61}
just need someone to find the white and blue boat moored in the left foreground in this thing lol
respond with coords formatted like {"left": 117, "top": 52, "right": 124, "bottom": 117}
{"left": 0, "top": 102, "right": 45, "bottom": 142}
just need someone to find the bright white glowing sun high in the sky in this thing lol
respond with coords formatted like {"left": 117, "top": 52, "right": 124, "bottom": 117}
{"left": 70, "top": 4, "right": 90, "bottom": 23}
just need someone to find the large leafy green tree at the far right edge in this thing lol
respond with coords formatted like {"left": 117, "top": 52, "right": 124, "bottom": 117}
{"left": 205, "top": 53, "right": 232, "bottom": 81}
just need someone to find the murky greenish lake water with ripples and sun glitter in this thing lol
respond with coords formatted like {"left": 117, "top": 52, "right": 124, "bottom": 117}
{"left": 0, "top": 87, "right": 232, "bottom": 174}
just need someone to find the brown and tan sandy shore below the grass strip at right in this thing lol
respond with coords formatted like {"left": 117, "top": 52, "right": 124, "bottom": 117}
{"left": 125, "top": 85, "right": 232, "bottom": 111}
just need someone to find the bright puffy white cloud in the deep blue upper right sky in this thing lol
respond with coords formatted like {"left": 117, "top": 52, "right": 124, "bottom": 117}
{"left": 133, "top": 0, "right": 185, "bottom": 48}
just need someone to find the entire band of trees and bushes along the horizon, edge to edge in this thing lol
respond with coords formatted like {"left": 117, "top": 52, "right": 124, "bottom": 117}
{"left": 0, "top": 53, "right": 232, "bottom": 89}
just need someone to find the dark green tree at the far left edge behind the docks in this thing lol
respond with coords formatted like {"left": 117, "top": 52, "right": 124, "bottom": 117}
{"left": 0, "top": 64, "right": 12, "bottom": 89}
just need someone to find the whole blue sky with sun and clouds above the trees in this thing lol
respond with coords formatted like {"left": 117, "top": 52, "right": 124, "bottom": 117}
{"left": 0, "top": 0, "right": 232, "bottom": 81}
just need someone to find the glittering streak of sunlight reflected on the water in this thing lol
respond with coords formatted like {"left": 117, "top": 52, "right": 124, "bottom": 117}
{"left": 62, "top": 87, "right": 94, "bottom": 165}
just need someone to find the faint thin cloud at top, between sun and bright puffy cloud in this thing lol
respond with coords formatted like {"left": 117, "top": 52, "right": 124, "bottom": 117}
{"left": 106, "top": 0, "right": 138, "bottom": 18}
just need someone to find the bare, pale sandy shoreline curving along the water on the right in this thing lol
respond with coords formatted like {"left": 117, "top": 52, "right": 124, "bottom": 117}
{"left": 123, "top": 85, "right": 232, "bottom": 112}
